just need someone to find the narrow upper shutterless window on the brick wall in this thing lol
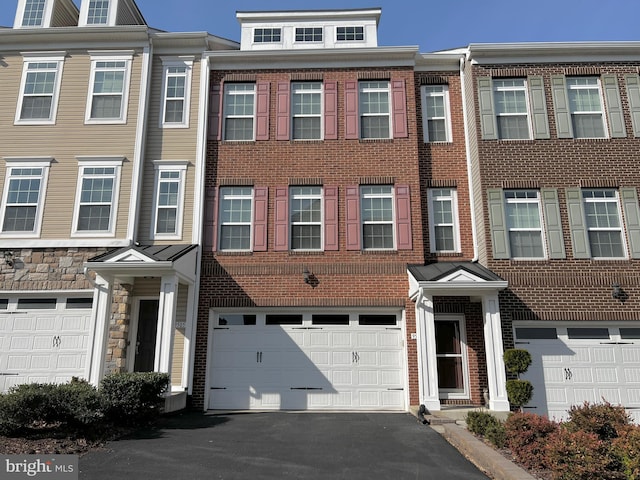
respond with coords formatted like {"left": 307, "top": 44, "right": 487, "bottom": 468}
{"left": 422, "top": 85, "right": 451, "bottom": 142}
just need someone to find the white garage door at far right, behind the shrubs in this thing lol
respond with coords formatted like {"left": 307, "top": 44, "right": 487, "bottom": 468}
{"left": 515, "top": 324, "right": 640, "bottom": 422}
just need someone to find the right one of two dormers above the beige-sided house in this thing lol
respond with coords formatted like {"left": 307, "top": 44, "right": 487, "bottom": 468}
{"left": 79, "top": 0, "right": 147, "bottom": 27}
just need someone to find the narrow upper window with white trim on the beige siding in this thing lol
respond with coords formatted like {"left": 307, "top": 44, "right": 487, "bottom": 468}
{"left": 160, "top": 58, "right": 193, "bottom": 128}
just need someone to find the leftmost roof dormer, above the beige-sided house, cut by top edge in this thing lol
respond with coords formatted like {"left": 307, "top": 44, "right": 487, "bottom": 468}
{"left": 13, "top": 0, "right": 78, "bottom": 28}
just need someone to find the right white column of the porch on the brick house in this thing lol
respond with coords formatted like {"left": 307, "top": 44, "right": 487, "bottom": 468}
{"left": 482, "top": 293, "right": 509, "bottom": 412}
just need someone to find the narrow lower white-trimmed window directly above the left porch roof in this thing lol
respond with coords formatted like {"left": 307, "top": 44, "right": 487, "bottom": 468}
{"left": 151, "top": 162, "right": 187, "bottom": 239}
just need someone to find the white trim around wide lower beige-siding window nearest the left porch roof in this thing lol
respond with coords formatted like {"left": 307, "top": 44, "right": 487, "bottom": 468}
{"left": 71, "top": 156, "right": 124, "bottom": 237}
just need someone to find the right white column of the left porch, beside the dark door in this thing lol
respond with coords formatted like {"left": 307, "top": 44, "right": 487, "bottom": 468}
{"left": 154, "top": 275, "right": 178, "bottom": 375}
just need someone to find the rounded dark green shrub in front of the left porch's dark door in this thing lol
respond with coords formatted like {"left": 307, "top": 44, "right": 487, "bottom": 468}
{"left": 99, "top": 372, "right": 169, "bottom": 425}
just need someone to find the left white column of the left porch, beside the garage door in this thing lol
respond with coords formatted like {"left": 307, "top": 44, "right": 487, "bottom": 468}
{"left": 86, "top": 275, "right": 113, "bottom": 387}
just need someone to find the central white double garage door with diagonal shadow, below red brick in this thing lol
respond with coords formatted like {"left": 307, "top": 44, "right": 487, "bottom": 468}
{"left": 209, "top": 314, "right": 405, "bottom": 410}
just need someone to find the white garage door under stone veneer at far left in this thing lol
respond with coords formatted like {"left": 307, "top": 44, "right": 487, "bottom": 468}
{"left": 0, "top": 297, "right": 92, "bottom": 392}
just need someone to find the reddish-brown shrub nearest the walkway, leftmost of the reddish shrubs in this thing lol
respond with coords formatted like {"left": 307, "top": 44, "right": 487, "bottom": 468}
{"left": 504, "top": 413, "right": 558, "bottom": 469}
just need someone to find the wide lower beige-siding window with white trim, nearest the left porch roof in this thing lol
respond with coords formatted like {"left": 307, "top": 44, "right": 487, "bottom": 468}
{"left": 73, "top": 159, "right": 122, "bottom": 236}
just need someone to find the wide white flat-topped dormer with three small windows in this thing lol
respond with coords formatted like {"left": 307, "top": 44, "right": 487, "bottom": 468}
{"left": 236, "top": 8, "right": 382, "bottom": 50}
